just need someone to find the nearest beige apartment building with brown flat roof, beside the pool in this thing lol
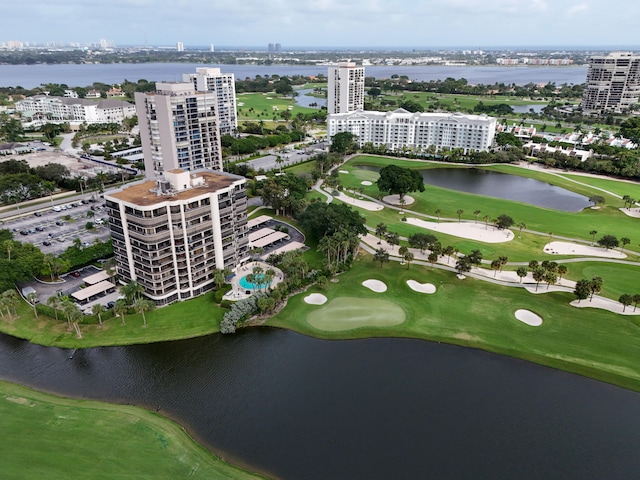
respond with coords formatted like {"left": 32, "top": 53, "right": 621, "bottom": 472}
{"left": 105, "top": 169, "right": 249, "bottom": 305}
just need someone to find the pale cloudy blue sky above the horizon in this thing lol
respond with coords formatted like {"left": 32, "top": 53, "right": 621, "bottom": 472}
{"left": 5, "top": 0, "right": 640, "bottom": 50}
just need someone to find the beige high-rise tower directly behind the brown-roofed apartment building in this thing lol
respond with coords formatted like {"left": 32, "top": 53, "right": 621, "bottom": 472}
{"left": 135, "top": 82, "right": 222, "bottom": 178}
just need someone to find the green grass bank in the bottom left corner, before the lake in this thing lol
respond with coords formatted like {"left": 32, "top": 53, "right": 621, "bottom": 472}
{"left": 0, "top": 382, "right": 262, "bottom": 480}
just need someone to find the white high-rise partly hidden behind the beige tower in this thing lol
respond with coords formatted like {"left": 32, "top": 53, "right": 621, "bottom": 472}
{"left": 182, "top": 67, "right": 238, "bottom": 135}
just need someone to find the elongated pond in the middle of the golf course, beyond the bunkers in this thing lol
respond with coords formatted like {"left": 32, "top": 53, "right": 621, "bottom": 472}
{"left": 358, "top": 166, "right": 590, "bottom": 212}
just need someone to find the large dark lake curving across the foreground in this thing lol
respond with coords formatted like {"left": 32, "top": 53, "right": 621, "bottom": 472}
{"left": 0, "top": 326, "right": 640, "bottom": 480}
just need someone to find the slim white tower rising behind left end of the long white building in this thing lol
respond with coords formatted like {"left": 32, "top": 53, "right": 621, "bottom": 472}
{"left": 327, "top": 62, "right": 364, "bottom": 114}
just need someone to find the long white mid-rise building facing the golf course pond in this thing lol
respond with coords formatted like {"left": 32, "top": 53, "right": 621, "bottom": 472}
{"left": 327, "top": 108, "right": 497, "bottom": 152}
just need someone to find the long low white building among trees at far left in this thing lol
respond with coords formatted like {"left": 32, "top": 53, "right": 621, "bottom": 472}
{"left": 15, "top": 95, "right": 136, "bottom": 123}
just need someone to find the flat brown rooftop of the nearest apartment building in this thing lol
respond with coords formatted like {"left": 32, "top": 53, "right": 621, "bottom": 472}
{"left": 107, "top": 170, "right": 244, "bottom": 207}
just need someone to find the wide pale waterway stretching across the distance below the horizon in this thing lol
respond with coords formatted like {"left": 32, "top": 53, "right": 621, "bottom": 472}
{"left": 0, "top": 63, "right": 587, "bottom": 88}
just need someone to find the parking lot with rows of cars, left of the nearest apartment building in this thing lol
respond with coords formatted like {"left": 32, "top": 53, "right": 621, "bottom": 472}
{"left": 0, "top": 196, "right": 110, "bottom": 255}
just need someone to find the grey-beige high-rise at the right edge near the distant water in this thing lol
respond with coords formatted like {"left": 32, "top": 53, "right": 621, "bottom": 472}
{"left": 582, "top": 52, "right": 640, "bottom": 113}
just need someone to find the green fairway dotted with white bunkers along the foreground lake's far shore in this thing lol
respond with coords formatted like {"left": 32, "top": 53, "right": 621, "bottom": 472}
{"left": 267, "top": 255, "right": 640, "bottom": 390}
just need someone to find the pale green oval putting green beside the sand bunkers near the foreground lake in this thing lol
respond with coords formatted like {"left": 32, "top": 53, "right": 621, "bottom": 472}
{"left": 307, "top": 297, "right": 406, "bottom": 332}
